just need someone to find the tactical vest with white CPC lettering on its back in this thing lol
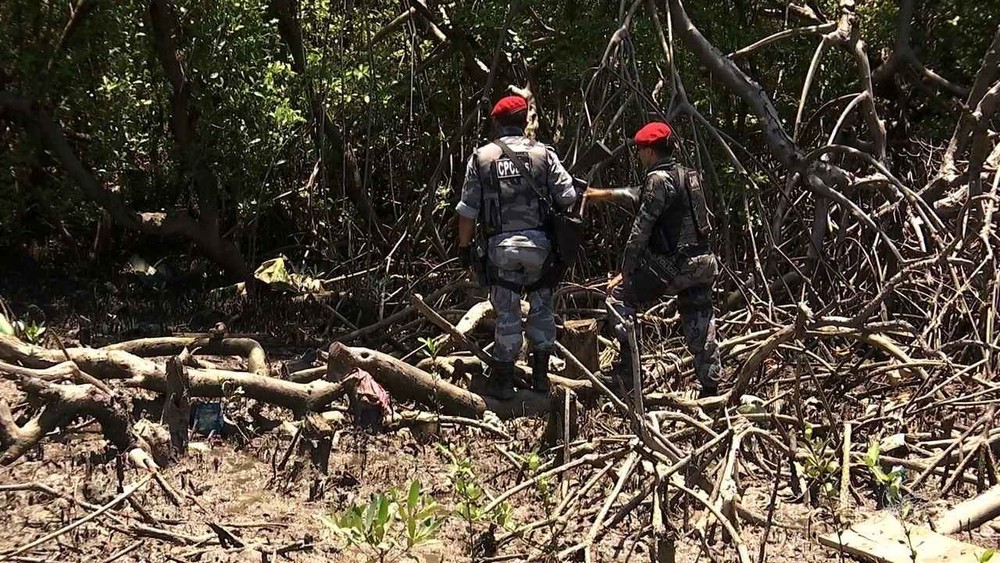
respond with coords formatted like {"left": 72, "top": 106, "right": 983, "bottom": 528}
{"left": 475, "top": 136, "right": 548, "bottom": 236}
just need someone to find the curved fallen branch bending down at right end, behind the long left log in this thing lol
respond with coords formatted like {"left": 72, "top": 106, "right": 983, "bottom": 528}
{"left": 101, "top": 336, "right": 270, "bottom": 375}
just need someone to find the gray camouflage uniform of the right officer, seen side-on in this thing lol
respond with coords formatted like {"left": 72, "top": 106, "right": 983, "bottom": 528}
{"left": 611, "top": 156, "right": 721, "bottom": 389}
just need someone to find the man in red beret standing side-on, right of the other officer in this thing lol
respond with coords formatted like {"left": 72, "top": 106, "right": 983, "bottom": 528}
{"left": 609, "top": 122, "right": 722, "bottom": 397}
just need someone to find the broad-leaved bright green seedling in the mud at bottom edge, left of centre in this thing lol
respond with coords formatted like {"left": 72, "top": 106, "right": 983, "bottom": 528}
{"left": 320, "top": 481, "right": 448, "bottom": 563}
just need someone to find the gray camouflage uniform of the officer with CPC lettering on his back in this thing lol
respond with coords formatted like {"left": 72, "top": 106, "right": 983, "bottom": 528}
{"left": 456, "top": 127, "right": 577, "bottom": 362}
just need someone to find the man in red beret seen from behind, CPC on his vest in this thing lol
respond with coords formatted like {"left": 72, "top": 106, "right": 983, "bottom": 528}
{"left": 456, "top": 96, "right": 577, "bottom": 400}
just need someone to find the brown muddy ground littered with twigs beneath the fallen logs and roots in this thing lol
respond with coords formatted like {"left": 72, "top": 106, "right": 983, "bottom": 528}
{"left": 0, "top": 262, "right": 1000, "bottom": 563}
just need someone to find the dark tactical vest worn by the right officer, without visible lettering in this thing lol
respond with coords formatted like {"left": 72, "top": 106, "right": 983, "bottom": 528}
{"left": 646, "top": 164, "right": 712, "bottom": 256}
